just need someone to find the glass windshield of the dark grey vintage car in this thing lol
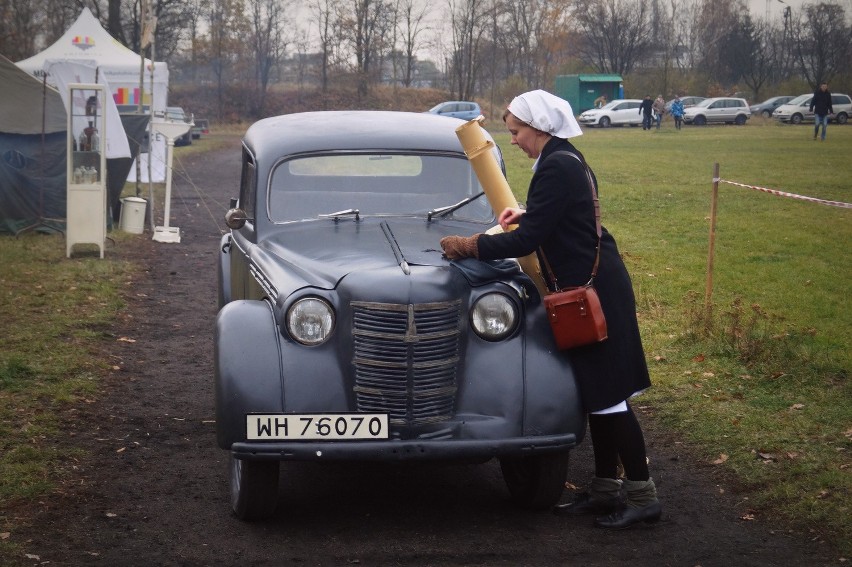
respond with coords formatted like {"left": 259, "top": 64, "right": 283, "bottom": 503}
{"left": 268, "top": 153, "right": 494, "bottom": 223}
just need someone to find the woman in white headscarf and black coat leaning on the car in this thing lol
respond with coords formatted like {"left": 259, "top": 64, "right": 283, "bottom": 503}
{"left": 441, "top": 90, "right": 662, "bottom": 529}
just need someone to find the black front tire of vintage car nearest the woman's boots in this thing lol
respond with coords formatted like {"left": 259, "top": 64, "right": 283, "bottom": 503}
{"left": 500, "top": 451, "right": 569, "bottom": 510}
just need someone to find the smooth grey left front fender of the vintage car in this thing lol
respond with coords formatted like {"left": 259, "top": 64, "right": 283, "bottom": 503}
{"left": 213, "top": 300, "right": 284, "bottom": 449}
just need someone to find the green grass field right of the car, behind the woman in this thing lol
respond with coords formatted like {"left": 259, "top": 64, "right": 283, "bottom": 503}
{"left": 494, "top": 119, "right": 852, "bottom": 554}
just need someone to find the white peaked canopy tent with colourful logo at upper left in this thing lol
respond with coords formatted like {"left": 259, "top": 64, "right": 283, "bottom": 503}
{"left": 16, "top": 8, "right": 169, "bottom": 182}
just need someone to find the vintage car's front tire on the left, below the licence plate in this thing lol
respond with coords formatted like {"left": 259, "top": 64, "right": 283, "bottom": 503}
{"left": 230, "top": 455, "right": 278, "bottom": 522}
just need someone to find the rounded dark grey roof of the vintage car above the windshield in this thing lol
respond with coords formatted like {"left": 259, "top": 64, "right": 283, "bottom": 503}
{"left": 243, "top": 110, "right": 476, "bottom": 158}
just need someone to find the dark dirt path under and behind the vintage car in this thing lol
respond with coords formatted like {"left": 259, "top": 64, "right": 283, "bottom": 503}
{"left": 8, "top": 135, "right": 838, "bottom": 567}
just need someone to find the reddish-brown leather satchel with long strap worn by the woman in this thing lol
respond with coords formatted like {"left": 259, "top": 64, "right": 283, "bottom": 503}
{"left": 539, "top": 152, "right": 608, "bottom": 350}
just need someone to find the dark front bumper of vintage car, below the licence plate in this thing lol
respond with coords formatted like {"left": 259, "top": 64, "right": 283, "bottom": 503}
{"left": 231, "top": 433, "right": 577, "bottom": 461}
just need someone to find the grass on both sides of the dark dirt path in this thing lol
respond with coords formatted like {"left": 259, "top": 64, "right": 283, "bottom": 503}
{"left": 0, "top": 119, "right": 852, "bottom": 556}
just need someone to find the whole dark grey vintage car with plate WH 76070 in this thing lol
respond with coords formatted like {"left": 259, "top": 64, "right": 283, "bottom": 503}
{"left": 215, "top": 111, "right": 586, "bottom": 520}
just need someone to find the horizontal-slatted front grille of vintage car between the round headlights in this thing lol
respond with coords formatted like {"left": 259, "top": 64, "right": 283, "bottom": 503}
{"left": 352, "top": 301, "right": 460, "bottom": 426}
